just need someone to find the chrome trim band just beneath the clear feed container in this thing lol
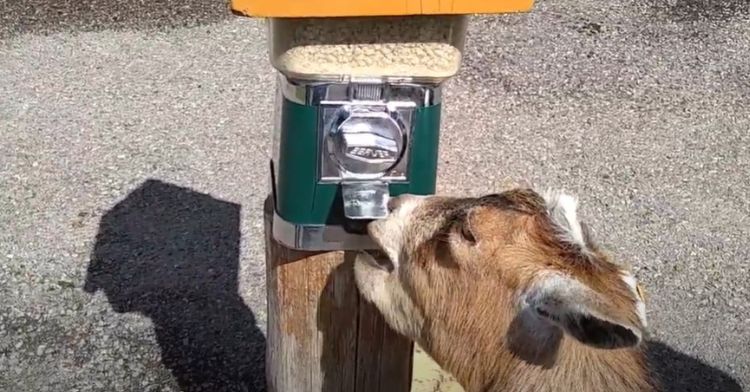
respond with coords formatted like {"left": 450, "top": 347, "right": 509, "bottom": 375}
{"left": 277, "top": 72, "right": 442, "bottom": 107}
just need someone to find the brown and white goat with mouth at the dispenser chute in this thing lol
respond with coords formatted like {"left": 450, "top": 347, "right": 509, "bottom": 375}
{"left": 355, "top": 189, "right": 656, "bottom": 392}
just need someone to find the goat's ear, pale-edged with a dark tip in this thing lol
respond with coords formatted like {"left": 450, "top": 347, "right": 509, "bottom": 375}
{"left": 522, "top": 274, "right": 642, "bottom": 349}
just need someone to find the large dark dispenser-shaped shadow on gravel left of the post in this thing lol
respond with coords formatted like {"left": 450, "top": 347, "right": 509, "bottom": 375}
{"left": 85, "top": 180, "right": 265, "bottom": 392}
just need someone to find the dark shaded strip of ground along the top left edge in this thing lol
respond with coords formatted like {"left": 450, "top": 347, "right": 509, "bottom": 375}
{"left": 0, "top": 0, "right": 233, "bottom": 38}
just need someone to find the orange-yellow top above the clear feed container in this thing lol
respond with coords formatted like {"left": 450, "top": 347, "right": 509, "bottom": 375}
{"left": 231, "top": 0, "right": 534, "bottom": 18}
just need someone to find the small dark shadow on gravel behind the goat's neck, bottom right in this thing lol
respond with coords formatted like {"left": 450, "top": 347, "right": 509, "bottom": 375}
{"left": 648, "top": 341, "right": 742, "bottom": 392}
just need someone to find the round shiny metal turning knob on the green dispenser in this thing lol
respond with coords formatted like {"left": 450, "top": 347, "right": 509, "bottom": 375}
{"left": 328, "top": 109, "right": 405, "bottom": 176}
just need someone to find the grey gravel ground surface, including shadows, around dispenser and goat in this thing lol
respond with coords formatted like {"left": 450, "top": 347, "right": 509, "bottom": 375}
{"left": 0, "top": 0, "right": 750, "bottom": 392}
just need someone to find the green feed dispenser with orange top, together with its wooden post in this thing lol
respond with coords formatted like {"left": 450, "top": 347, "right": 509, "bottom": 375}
{"left": 231, "top": 0, "right": 533, "bottom": 392}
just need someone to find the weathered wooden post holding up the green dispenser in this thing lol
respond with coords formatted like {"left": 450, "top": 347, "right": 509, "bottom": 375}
{"left": 264, "top": 197, "right": 413, "bottom": 392}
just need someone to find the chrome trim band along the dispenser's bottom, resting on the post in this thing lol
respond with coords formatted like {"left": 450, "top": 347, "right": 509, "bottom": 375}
{"left": 273, "top": 212, "right": 378, "bottom": 251}
